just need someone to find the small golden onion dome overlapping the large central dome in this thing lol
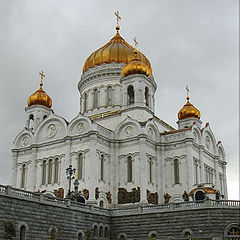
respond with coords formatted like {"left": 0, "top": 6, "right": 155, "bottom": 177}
{"left": 122, "top": 51, "right": 151, "bottom": 77}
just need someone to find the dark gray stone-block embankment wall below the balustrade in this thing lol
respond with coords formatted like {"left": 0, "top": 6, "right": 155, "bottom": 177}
{"left": 0, "top": 195, "right": 240, "bottom": 240}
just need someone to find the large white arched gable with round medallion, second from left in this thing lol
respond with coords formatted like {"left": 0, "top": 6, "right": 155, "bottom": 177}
{"left": 34, "top": 114, "right": 67, "bottom": 143}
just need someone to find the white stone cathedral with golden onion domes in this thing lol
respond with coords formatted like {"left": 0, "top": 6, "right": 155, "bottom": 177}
{"left": 12, "top": 21, "right": 227, "bottom": 208}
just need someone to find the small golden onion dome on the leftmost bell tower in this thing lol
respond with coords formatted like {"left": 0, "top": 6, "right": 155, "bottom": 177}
{"left": 27, "top": 80, "right": 52, "bottom": 108}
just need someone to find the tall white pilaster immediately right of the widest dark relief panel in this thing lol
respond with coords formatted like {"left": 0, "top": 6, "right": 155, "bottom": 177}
{"left": 139, "top": 137, "right": 148, "bottom": 203}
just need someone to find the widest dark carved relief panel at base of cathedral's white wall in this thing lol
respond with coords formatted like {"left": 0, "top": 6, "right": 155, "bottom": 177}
{"left": 118, "top": 187, "right": 140, "bottom": 204}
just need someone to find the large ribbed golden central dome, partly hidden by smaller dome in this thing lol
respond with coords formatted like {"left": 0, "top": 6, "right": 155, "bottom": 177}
{"left": 83, "top": 28, "right": 152, "bottom": 75}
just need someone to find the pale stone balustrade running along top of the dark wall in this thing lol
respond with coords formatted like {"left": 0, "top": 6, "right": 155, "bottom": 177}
{"left": 0, "top": 185, "right": 240, "bottom": 216}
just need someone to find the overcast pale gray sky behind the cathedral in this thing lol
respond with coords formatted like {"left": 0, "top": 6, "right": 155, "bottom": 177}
{"left": 0, "top": 0, "right": 239, "bottom": 199}
